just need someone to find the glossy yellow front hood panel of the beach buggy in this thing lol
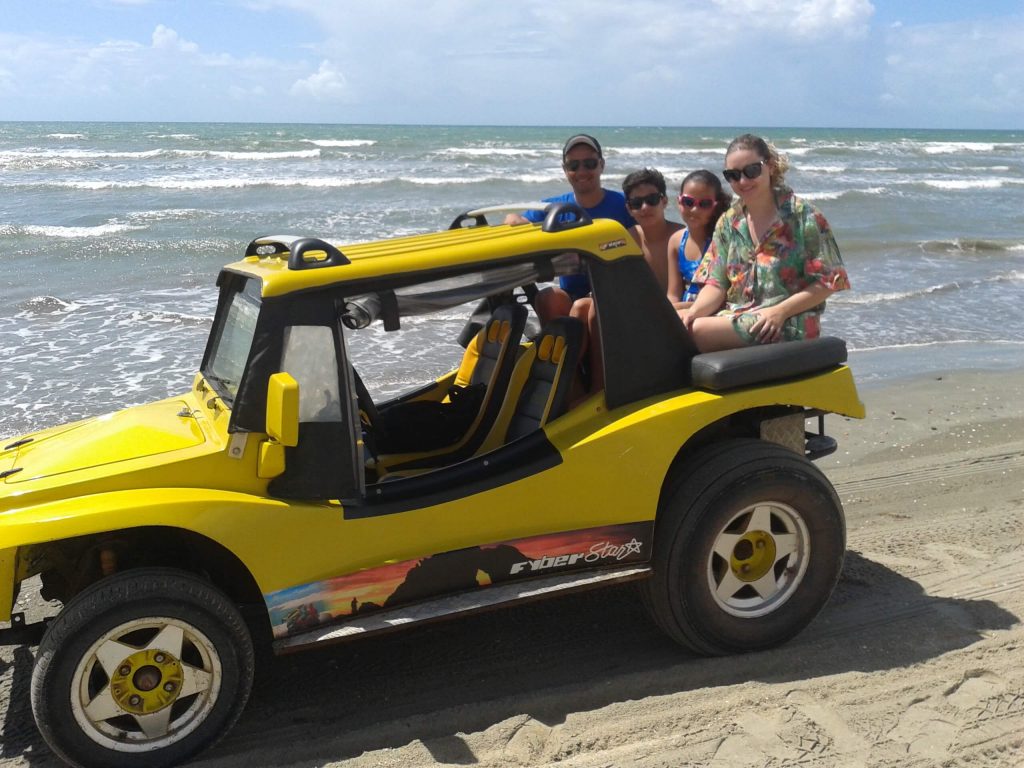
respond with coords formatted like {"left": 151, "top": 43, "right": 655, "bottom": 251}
{"left": 0, "top": 399, "right": 206, "bottom": 483}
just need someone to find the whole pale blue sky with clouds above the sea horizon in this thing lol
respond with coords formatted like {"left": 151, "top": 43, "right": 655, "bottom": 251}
{"left": 0, "top": 0, "right": 1024, "bottom": 128}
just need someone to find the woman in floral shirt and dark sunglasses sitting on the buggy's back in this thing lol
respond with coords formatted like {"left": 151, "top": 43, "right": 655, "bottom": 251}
{"left": 680, "top": 133, "right": 850, "bottom": 352}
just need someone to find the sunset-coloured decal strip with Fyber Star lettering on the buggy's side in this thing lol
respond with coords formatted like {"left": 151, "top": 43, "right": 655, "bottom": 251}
{"left": 264, "top": 522, "right": 652, "bottom": 637}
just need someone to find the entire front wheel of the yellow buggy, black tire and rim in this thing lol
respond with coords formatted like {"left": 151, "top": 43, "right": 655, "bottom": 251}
{"left": 32, "top": 568, "right": 254, "bottom": 768}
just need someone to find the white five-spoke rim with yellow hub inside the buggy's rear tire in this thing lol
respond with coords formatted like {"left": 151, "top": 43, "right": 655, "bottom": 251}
{"left": 708, "top": 502, "right": 810, "bottom": 618}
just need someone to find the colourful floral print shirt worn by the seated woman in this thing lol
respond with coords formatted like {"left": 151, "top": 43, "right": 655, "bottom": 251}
{"left": 693, "top": 187, "right": 850, "bottom": 338}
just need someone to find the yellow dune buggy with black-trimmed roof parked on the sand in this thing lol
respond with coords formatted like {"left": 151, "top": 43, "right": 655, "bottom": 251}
{"left": 0, "top": 204, "right": 863, "bottom": 768}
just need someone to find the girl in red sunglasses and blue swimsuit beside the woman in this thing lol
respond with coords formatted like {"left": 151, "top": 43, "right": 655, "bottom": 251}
{"left": 667, "top": 170, "right": 732, "bottom": 309}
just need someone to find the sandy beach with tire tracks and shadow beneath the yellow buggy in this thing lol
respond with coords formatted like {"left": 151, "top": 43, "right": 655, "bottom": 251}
{"left": 0, "top": 371, "right": 1024, "bottom": 768}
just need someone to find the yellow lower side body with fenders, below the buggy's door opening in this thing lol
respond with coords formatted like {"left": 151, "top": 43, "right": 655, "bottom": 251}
{"left": 0, "top": 360, "right": 863, "bottom": 621}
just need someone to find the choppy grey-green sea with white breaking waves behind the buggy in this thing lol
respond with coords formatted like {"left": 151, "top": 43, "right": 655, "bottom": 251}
{"left": 0, "top": 123, "right": 1024, "bottom": 435}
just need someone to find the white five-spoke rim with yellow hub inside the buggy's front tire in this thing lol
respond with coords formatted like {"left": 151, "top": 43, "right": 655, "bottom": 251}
{"left": 71, "top": 616, "right": 223, "bottom": 752}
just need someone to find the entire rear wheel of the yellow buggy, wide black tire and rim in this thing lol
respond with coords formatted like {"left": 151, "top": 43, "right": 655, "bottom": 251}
{"left": 644, "top": 439, "right": 846, "bottom": 655}
